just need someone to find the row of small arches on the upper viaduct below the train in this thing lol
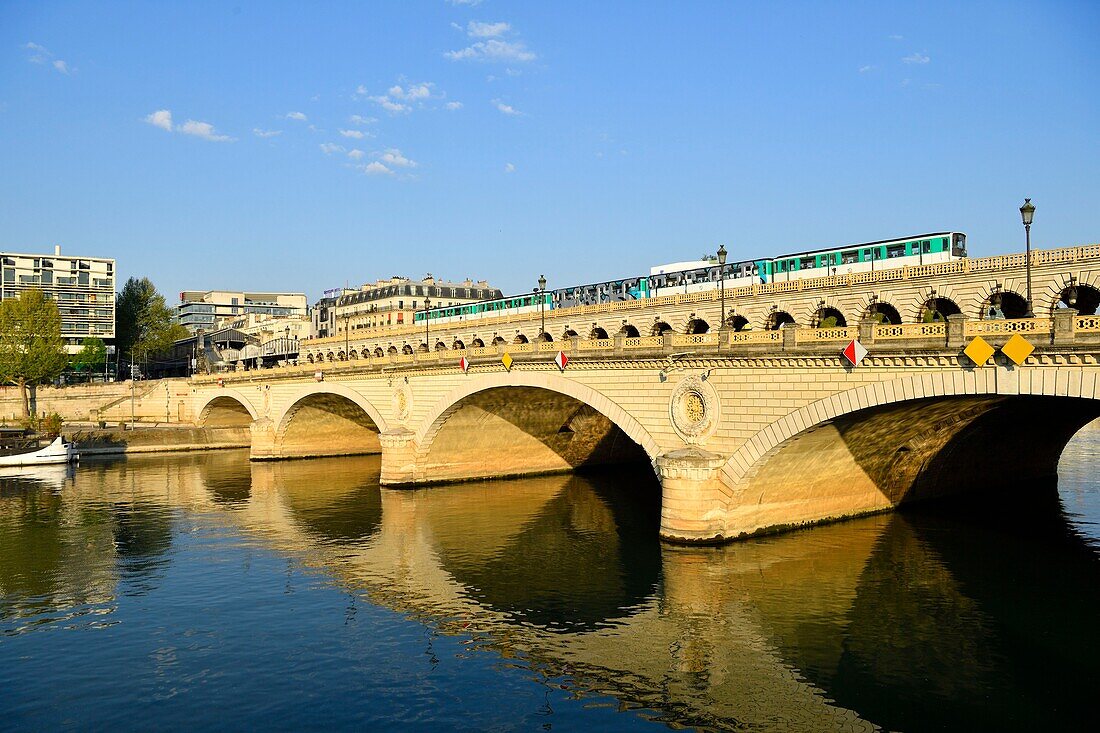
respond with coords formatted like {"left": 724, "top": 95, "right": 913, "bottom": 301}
{"left": 301, "top": 277, "right": 1100, "bottom": 364}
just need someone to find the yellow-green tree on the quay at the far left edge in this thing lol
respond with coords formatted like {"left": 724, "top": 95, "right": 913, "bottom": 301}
{"left": 0, "top": 289, "right": 68, "bottom": 417}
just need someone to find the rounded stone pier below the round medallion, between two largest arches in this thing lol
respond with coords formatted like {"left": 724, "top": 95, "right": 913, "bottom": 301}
{"left": 656, "top": 448, "right": 728, "bottom": 543}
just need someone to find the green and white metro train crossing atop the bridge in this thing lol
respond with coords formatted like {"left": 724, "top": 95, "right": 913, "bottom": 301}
{"left": 413, "top": 231, "right": 967, "bottom": 324}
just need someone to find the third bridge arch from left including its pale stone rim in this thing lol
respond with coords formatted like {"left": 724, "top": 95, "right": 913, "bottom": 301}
{"left": 414, "top": 372, "right": 660, "bottom": 482}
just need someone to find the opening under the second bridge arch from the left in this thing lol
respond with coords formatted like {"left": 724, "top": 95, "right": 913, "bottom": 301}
{"left": 274, "top": 392, "right": 382, "bottom": 458}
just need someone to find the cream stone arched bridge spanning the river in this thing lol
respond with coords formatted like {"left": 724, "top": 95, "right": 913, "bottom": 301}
{"left": 190, "top": 248, "right": 1100, "bottom": 541}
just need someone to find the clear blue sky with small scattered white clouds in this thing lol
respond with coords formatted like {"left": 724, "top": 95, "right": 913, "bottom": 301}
{"left": 0, "top": 0, "right": 1100, "bottom": 299}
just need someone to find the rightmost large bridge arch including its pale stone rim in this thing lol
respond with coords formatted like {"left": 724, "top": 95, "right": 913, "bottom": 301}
{"left": 722, "top": 368, "right": 1100, "bottom": 536}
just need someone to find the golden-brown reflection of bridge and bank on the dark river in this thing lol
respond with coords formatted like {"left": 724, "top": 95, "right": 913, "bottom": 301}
{"left": 0, "top": 440, "right": 1100, "bottom": 730}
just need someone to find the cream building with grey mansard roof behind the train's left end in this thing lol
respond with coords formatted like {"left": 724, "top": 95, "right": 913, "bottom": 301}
{"left": 327, "top": 273, "right": 504, "bottom": 336}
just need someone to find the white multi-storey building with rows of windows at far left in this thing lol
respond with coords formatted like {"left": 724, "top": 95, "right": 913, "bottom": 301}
{"left": 0, "top": 244, "right": 116, "bottom": 353}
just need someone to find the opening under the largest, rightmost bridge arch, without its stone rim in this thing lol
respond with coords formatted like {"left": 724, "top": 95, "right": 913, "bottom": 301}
{"left": 732, "top": 387, "right": 1100, "bottom": 534}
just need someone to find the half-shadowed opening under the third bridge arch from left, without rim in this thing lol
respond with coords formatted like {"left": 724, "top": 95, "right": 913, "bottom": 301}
{"left": 421, "top": 386, "right": 649, "bottom": 482}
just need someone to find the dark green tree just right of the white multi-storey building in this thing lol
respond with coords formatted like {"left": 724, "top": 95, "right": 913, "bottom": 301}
{"left": 114, "top": 277, "right": 189, "bottom": 374}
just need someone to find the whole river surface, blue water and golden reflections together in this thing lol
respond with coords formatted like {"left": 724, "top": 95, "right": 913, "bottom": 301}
{"left": 0, "top": 426, "right": 1100, "bottom": 731}
